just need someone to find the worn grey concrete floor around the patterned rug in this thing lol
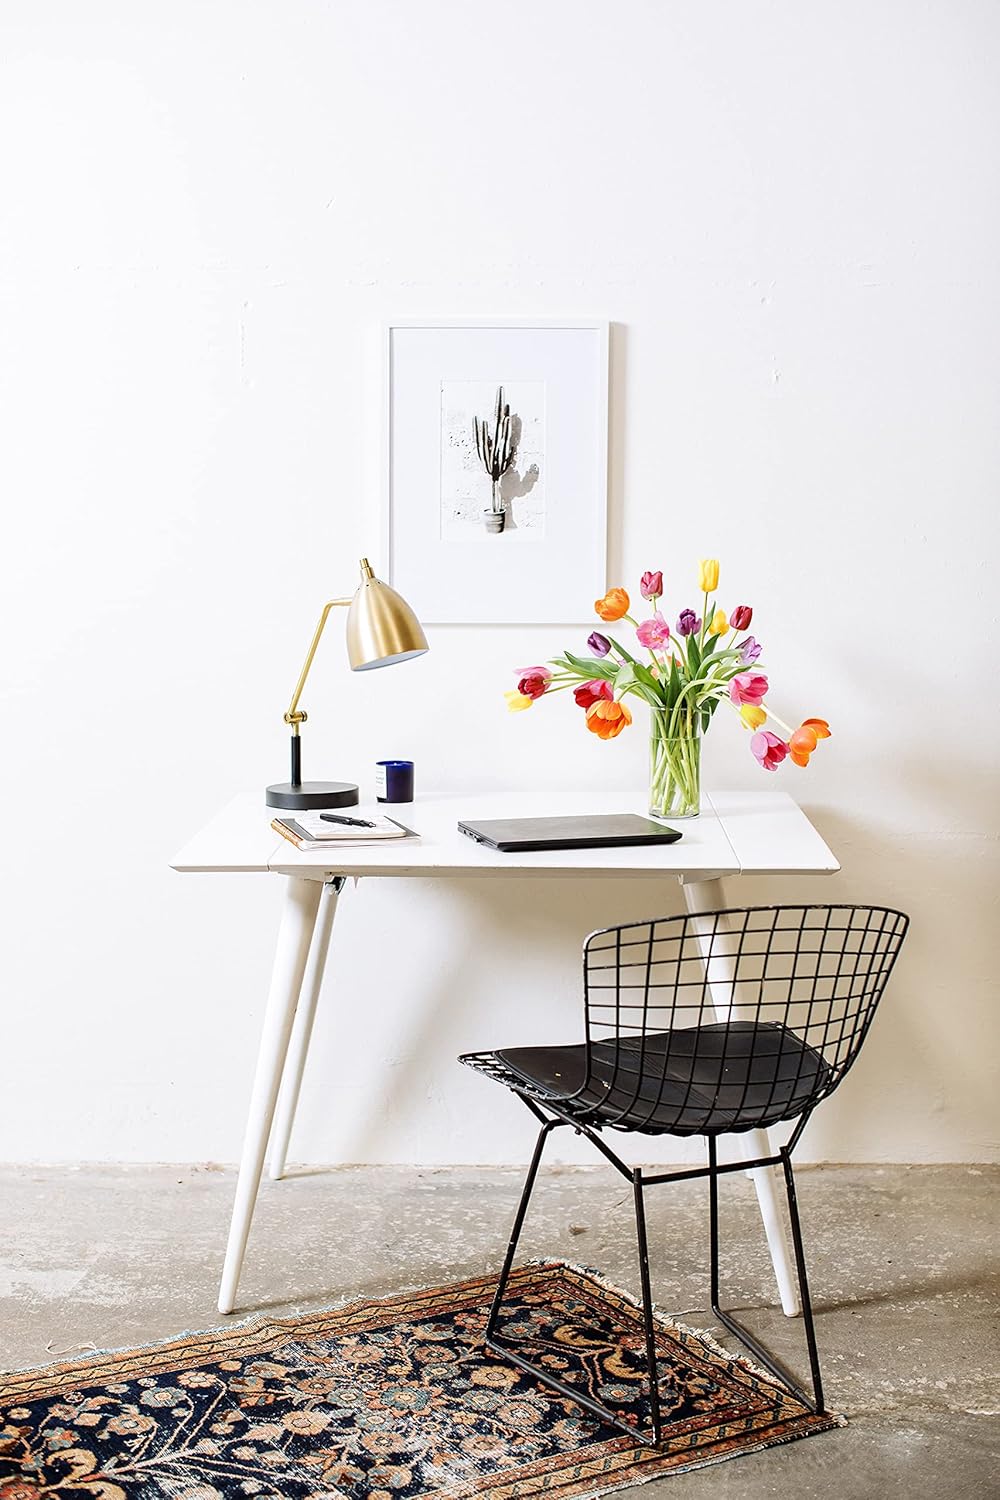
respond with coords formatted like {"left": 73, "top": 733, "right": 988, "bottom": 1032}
{"left": 0, "top": 1167, "right": 1000, "bottom": 1500}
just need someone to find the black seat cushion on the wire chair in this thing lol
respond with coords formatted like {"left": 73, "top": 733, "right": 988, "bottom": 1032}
{"left": 493, "top": 1020, "right": 829, "bottom": 1136}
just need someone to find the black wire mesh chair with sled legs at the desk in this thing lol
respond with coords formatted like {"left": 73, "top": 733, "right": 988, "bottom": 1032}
{"left": 459, "top": 906, "right": 909, "bottom": 1446}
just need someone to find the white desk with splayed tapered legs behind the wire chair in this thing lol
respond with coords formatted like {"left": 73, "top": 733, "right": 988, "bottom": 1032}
{"left": 171, "top": 792, "right": 840, "bottom": 1316}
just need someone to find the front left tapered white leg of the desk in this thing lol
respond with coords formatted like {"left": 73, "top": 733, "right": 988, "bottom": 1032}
{"left": 219, "top": 878, "right": 322, "bottom": 1313}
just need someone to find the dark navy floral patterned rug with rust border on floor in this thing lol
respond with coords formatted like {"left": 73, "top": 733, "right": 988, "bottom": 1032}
{"left": 0, "top": 1262, "right": 838, "bottom": 1500}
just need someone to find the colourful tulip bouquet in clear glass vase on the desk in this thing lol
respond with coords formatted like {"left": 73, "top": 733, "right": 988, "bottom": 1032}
{"left": 507, "top": 558, "right": 831, "bottom": 818}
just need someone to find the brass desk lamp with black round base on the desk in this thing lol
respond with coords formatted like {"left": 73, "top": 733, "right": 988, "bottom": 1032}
{"left": 267, "top": 558, "right": 427, "bottom": 809}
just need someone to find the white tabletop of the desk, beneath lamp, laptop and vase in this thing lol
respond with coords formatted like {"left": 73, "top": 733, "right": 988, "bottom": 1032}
{"left": 171, "top": 791, "right": 840, "bottom": 882}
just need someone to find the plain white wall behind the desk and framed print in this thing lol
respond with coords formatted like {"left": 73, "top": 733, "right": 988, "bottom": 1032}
{"left": 0, "top": 0, "right": 1000, "bottom": 1161}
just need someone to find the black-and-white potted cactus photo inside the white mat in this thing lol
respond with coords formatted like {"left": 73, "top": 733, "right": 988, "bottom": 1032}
{"left": 441, "top": 381, "right": 546, "bottom": 540}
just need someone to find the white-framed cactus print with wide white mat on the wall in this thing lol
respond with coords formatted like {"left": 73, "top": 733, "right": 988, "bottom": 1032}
{"left": 382, "top": 320, "right": 609, "bottom": 626}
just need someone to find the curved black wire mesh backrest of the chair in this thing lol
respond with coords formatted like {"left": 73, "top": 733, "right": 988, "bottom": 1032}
{"left": 577, "top": 906, "right": 909, "bottom": 1134}
